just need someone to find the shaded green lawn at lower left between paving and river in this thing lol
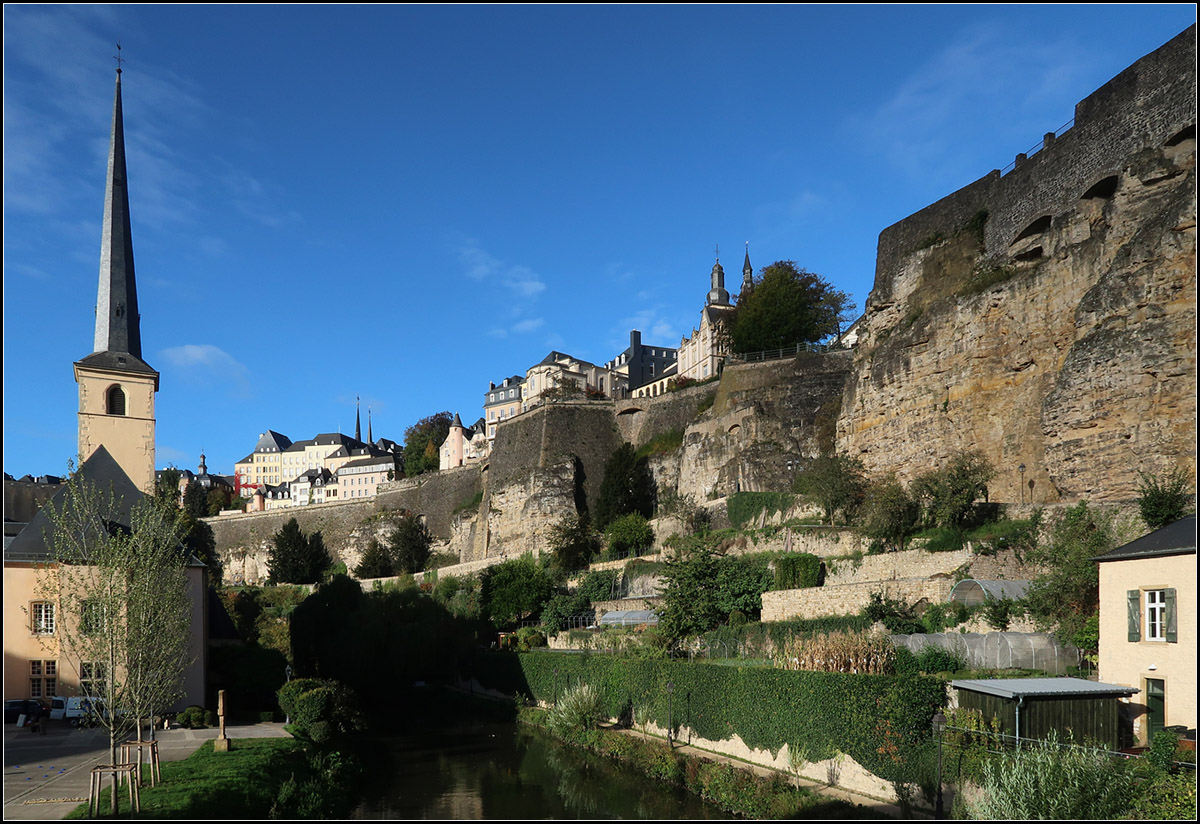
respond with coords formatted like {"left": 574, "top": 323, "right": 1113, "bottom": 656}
{"left": 66, "top": 738, "right": 305, "bottom": 819}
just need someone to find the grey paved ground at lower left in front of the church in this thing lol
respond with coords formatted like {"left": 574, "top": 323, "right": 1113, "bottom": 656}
{"left": 4, "top": 721, "right": 287, "bottom": 822}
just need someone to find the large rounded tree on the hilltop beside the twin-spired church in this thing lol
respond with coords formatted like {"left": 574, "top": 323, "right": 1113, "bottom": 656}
{"left": 730, "top": 260, "right": 854, "bottom": 351}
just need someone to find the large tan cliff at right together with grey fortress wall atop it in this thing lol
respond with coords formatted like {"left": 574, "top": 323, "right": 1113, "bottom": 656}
{"left": 838, "top": 28, "right": 1196, "bottom": 503}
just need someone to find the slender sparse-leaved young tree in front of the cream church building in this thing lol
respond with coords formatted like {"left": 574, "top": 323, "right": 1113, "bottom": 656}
{"left": 38, "top": 477, "right": 193, "bottom": 812}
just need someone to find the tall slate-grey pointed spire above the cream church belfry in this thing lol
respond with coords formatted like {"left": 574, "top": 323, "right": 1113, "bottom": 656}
{"left": 94, "top": 59, "right": 142, "bottom": 360}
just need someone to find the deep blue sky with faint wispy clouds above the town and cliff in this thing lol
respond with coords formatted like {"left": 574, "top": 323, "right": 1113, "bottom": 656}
{"left": 4, "top": 4, "right": 1195, "bottom": 477}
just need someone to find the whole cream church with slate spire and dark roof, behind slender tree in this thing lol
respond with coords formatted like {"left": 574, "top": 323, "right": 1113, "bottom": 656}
{"left": 4, "top": 68, "right": 208, "bottom": 709}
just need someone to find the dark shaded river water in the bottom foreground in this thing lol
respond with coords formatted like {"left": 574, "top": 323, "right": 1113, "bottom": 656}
{"left": 352, "top": 721, "right": 730, "bottom": 819}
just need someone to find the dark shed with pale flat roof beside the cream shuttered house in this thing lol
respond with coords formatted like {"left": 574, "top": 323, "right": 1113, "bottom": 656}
{"left": 950, "top": 678, "right": 1138, "bottom": 750}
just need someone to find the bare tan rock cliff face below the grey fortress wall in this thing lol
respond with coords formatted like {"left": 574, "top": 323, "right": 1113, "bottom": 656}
{"left": 838, "top": 138, "right": 1196, "bottom": 501}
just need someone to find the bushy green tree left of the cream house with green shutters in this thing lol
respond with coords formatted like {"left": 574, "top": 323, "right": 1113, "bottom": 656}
{"left": 1025, "top": 501, "right": 1116, "bottom": 652}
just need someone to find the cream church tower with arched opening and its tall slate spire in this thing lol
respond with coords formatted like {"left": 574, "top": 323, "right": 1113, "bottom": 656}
{"left": 74, "top": 67, "right": 158, "bottom": 494}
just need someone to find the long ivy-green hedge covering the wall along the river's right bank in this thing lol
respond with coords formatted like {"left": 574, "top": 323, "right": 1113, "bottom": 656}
{"left": 476, "top": 651, "right": 946, "bottom": 782}
